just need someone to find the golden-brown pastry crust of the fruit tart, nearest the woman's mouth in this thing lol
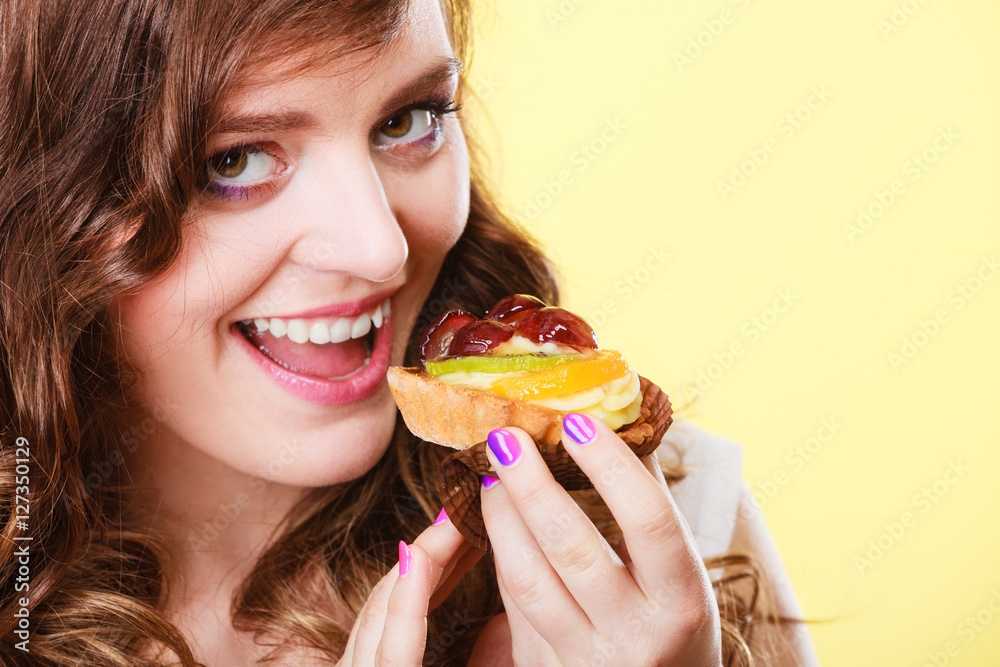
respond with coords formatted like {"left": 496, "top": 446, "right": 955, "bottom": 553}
{"left": 386, "top": 366, "right": 562, "bottom": 449}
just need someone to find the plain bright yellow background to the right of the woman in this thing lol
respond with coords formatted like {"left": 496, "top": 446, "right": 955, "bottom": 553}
{"left": 467, "top": 0, "right": 1000, "bottom": 667}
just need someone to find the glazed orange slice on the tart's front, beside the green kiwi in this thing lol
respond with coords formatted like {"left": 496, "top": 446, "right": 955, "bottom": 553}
{"left": 490, "top": 350, "right": 629, "bottom": 401}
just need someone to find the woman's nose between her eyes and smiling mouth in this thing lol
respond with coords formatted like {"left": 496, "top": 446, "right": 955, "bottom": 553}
{"left": 290, "top": 151, "right": 409, "bottom": 283}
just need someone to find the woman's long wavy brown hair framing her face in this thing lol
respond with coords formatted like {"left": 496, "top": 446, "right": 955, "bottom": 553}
{"left": 0, "top": 0, "right": 780, "bottom": 667}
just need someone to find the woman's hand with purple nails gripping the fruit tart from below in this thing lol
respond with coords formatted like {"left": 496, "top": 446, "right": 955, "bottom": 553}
{"left": 473, "top": 415, "right": 721, "bottom": 667}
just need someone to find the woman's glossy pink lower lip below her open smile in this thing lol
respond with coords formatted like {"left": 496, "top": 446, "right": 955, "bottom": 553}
{"left": 229, "top": 313, "right": 393, "bottom": 405}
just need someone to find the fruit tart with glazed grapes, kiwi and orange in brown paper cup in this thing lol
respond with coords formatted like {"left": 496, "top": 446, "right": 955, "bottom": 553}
{"left": 387, "top": 294, "right": 672, "bottom": 549}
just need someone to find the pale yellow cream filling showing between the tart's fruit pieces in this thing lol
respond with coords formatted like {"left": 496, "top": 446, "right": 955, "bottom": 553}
{"left": 438, "top": 336, "right": 642, "bottom": 429}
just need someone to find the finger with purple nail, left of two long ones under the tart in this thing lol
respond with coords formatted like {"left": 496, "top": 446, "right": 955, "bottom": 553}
{"left": 483, "top": 428, "right": 640, "bottom": 626}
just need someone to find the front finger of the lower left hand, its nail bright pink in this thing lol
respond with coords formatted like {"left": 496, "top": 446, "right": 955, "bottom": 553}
{"left": 376, "top": 542, "right": 431, "bottom": 667}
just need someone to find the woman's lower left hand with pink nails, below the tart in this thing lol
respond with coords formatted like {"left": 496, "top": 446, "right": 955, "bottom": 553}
{"left": 337, "top": 510, "right": 483, "bottom": 667}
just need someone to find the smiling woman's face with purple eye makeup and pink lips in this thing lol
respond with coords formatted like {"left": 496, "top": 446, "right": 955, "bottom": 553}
{"left": 115, "top": 0, "right": 469, "bottom": 486}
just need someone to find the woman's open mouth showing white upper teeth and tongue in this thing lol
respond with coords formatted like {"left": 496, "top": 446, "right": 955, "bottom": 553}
{"left": 235, "top": 298, "right": 389, "bottom": 382}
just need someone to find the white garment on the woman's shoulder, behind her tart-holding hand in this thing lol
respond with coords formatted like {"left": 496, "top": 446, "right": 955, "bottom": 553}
{"left": 657, "top": 420, "right": 743, "bottom": 558}
